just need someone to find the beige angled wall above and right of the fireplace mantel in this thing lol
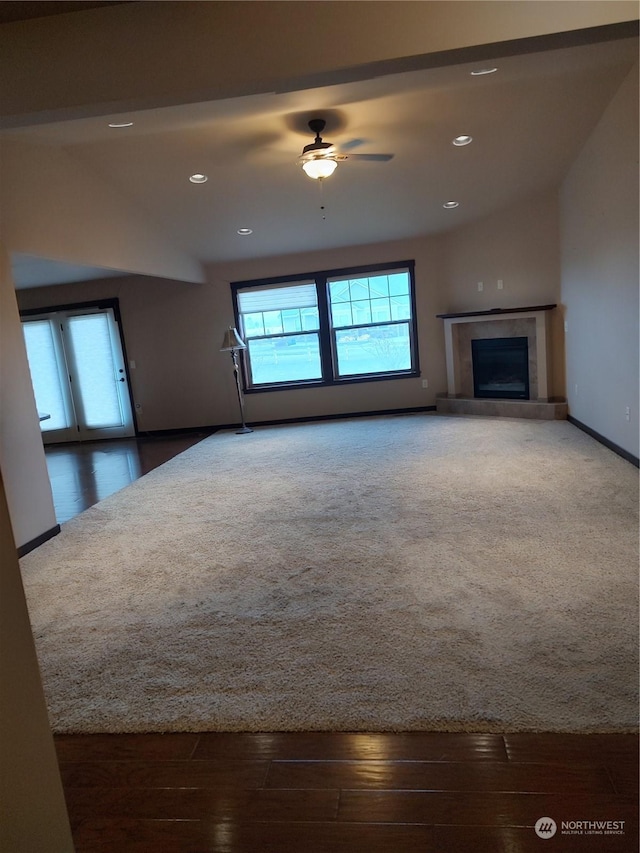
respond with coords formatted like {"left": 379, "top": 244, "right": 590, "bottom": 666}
{"left": 441, "top": 189, "right": 566, "bottom": 398}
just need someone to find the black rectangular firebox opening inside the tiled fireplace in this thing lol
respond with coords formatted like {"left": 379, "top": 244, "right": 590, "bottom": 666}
{"left": 471, "top": 337, "right": 529, "bottom": 400}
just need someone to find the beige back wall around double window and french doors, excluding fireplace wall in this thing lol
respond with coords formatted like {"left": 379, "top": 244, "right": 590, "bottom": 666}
{"left": 18, "top": 238, "right": 446, "bottom": 431}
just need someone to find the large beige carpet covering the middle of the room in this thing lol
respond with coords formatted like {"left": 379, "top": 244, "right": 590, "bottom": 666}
{"left": 21, "top": 414, "right": 638, "bottom": 732}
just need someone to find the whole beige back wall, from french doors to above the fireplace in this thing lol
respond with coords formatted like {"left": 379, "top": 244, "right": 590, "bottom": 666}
{"left": 18, "top": 192, "right": 564, "bottom": 431}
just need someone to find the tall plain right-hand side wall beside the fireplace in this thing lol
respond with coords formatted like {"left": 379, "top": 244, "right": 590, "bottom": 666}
{"left": 560, "top": 66, "right": 639, "bottom": 457}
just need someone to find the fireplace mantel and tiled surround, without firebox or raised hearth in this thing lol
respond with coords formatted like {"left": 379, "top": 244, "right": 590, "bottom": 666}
{"left": 436, "top": 304, "right": 556, "bottom": 403}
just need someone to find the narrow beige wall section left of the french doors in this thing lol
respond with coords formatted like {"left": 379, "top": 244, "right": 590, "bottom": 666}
{"left": 0, "top": 246, "right": 56, "bottom": 546}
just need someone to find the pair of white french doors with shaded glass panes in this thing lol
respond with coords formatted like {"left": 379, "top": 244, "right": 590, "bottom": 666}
{"left": 22, "top": 308, "right": 135, "bottom": 444}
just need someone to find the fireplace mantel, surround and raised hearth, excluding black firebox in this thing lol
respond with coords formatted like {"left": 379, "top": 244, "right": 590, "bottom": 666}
{"left": 436, "top": 305, "right": 567, "bottom": 420}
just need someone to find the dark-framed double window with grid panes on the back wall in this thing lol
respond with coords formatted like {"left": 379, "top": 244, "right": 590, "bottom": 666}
{"left": 231, "top": 261, "right": 419, "bottom": 391}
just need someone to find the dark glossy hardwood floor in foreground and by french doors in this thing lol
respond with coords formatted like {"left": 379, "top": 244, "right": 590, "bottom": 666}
{"left": 42, "top": 435, "right": 638, "bottom": 853}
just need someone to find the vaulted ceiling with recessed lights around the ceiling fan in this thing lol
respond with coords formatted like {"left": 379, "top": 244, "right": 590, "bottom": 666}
{"left": 4, "top": 26, "right": 638, "bottom": 287}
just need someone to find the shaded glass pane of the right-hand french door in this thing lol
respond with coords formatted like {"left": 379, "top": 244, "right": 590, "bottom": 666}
{"left": 67, "top": 314, "right": 123, "bottom": 429}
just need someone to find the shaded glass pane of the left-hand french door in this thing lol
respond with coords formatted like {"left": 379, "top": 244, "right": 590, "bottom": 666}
{"left": 22, "top": 320, "right": 71, "bottom": 432}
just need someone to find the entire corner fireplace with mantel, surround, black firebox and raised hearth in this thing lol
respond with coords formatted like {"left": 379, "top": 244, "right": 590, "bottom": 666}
{"left": 436, "top": 305, "right": 567, "bottom": 419}
